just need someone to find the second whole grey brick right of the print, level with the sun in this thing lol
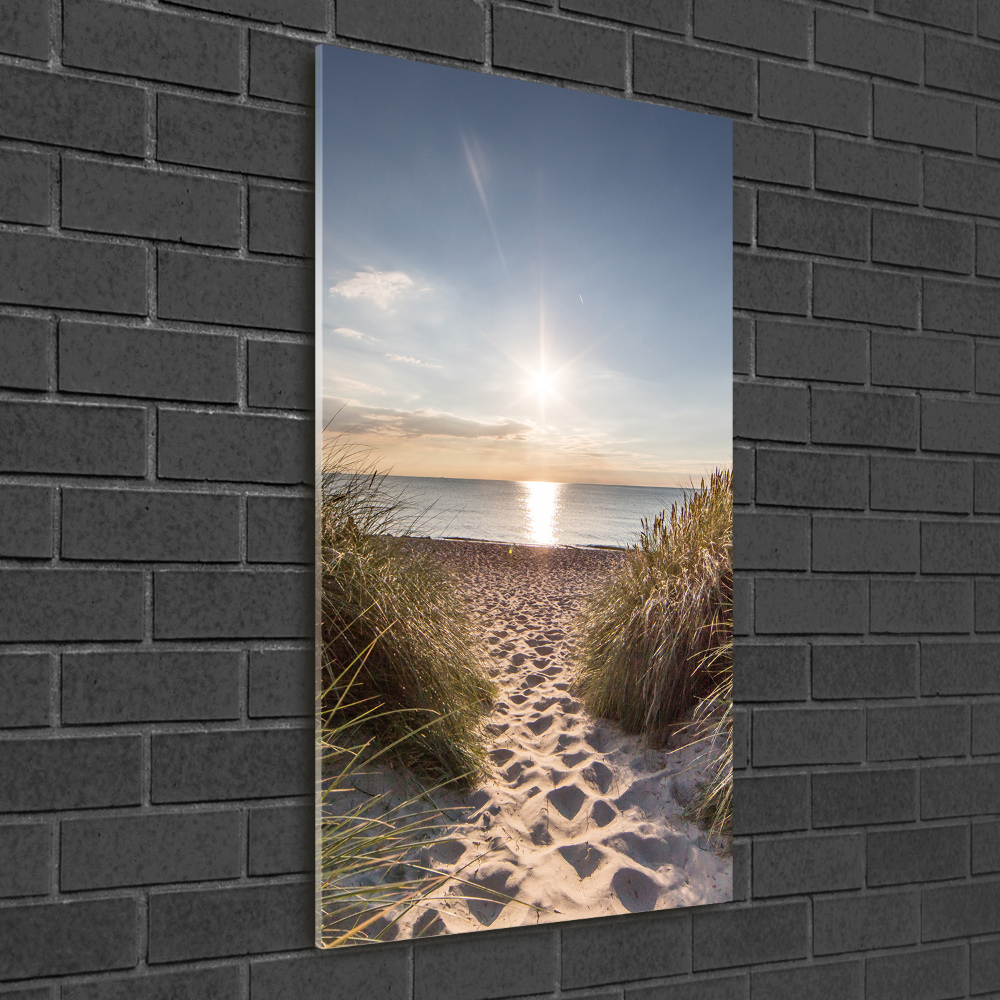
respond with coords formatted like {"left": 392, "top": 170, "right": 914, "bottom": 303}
{"left": 872, "top": 331, "right": 972, "bottom": 391}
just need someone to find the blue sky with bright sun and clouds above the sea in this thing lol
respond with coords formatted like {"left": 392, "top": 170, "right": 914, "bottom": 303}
{"left": 317, "top": 46, "right": 732, "bottom": 486}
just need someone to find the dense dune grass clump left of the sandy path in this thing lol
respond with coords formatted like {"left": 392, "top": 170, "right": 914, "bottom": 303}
{"left": 320, "top": 441, "right": 496, "bottom": 787}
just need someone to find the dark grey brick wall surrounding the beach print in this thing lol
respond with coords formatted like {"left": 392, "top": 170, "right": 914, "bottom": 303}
{"left": 0, "top": 0, "right": 1000, "bottom": 1000}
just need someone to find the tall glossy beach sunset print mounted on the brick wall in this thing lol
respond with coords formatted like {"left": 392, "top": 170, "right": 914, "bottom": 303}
{"left": 316, "top": 46, "right": 732, "bottom": 948}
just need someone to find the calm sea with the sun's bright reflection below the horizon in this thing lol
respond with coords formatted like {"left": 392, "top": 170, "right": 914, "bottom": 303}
{"left": 372, "top": 476, "right": 684, "bottom": 546}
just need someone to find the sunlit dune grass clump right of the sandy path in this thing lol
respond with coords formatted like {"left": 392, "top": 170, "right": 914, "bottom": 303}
{"left": 577, "top": 469, "right": 733, "bottom": 832}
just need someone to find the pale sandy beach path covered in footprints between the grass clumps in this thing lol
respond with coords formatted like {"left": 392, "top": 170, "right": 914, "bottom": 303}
{"left": 324, "top": 541, "right": 732, "bottom": 938}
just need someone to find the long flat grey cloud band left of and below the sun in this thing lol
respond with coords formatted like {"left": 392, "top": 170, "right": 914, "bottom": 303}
{"left": 323, "top": 396, "right": 534, "bottom": 441}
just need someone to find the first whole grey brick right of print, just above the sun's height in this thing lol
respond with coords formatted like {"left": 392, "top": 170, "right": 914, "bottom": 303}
{"left": 756, "top": 319, "right": 868, "bottom": 383}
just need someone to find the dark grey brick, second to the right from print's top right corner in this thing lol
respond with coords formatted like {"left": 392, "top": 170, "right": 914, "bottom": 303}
{"left": 816, "top": 135, "right": 921, "bottom": 205}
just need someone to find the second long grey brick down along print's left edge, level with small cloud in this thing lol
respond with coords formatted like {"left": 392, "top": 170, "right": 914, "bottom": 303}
{"left": 157, "top": 250, "right": 313, "bottom": 332}
